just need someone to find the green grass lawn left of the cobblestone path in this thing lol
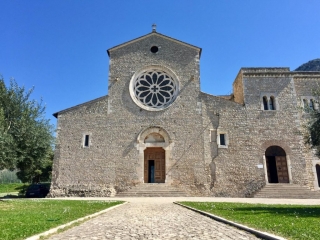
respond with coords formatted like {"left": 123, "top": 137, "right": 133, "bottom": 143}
{"left": 0, "top": 199, "right": 122, "bottom": 240}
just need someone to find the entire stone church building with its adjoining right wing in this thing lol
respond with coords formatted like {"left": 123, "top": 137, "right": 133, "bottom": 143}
{"left": 50, "top": 29, "right": 320, "bottom": 197}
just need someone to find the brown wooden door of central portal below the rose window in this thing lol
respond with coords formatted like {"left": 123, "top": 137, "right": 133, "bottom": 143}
{"left": 144, "top": 148, "right": 166, "bottom": 183}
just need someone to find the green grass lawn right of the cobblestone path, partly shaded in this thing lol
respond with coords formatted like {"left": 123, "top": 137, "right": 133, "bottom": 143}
{"left": 180, "top": 202, "right": 320, "bottom": 239}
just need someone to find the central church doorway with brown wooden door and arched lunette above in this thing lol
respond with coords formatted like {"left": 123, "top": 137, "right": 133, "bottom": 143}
{"left": 144, "top": 132, "right": 166, "bottom": 183}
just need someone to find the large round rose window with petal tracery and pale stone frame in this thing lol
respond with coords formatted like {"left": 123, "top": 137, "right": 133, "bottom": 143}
{"left": 130, "top": 69, "right": 179, "bottom": 111}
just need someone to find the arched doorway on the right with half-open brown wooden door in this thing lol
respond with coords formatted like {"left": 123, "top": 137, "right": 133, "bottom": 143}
{"left": 265, "top": 146, "right": 289, "bottom": 183}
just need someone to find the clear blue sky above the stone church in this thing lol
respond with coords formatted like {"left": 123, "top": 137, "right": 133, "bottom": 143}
{"left": 0, "top": 0, "right": 320, "bottom": 127}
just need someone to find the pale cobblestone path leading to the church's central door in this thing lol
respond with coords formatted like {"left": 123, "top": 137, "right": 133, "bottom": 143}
{"left": 50, "top": 200, "right": 257, "bottom": 240}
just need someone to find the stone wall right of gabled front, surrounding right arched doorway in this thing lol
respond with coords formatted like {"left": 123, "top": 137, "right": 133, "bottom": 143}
{"left": 203, "top": 73, "right": 316, "bottom": 197}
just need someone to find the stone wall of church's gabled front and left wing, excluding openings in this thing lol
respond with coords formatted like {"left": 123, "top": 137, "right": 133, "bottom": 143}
{"left": 51, "top": 35, "right": 208, "bottom": 196}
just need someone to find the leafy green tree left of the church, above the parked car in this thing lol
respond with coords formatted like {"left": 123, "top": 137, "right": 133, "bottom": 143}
{"left": 0, "top": 76, "right": 53, "bottom": 182}
